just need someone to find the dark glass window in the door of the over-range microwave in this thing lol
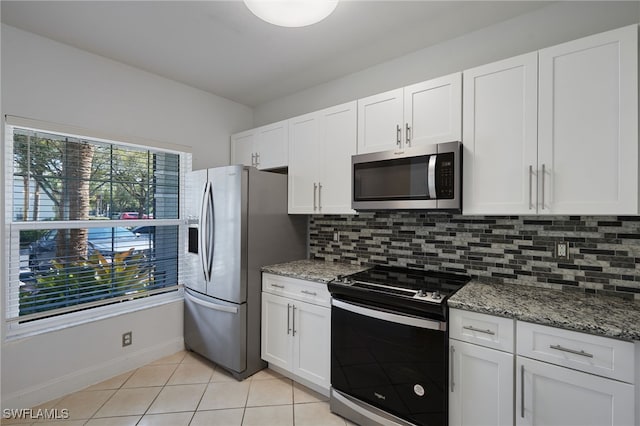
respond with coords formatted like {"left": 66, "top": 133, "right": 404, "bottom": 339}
{"left": 353, "top": 155, "right": 430, "bottom": 201}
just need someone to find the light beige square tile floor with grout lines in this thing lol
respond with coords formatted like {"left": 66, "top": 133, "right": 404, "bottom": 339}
{"left": 2, "top": 351, "right": 352, "bottom": 426}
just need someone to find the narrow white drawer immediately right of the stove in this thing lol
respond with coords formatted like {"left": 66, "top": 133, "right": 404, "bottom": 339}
{"left": 449, "top": 309, "right": 515, "bottom": 352}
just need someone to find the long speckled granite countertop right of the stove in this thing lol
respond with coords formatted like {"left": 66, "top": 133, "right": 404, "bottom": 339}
{"left": 448, "top": 280, "right": 640, "bottom": 341}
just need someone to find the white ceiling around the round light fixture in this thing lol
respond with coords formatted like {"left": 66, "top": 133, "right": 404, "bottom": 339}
{"left": 1, "top": 0, "right": 548, "bottom": 107}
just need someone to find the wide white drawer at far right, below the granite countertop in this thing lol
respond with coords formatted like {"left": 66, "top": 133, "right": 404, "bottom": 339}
{"left": 517, "top": 321, "right": 635, "bottom": 383}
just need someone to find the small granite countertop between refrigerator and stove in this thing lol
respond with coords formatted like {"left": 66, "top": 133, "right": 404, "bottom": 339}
{"left": 262, "top": 260, "right": 369, "bottom": 283}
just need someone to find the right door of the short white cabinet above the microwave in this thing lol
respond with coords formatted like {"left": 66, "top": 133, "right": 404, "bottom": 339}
{"left": 403, "top": 73, "right": 462, "bottom": 146}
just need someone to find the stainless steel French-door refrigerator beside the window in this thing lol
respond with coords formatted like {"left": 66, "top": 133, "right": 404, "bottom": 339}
{"left": 184, "top": 166, "right": 307, "bottom": 380}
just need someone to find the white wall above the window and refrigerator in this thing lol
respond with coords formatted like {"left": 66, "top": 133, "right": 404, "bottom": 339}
{"left": 2, "top": 25, "right": 252, "bottom": 169}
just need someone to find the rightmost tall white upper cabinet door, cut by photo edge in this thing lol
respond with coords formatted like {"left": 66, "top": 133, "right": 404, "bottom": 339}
{"left": 538, "top": 25, "right": 638, "bottom": 214}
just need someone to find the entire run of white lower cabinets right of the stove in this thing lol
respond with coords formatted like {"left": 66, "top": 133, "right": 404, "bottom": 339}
{"left": 449, "top": 309, "right": 640, "bottom": 426}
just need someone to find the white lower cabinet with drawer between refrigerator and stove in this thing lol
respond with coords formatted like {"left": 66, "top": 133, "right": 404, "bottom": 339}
{"left": 261, "top": 274, "right": 331, "bottom": 395}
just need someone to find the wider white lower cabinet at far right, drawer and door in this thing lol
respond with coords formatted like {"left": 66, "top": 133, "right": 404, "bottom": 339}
{"left": 516, "top": 321, "right": 637, "bottom": 426}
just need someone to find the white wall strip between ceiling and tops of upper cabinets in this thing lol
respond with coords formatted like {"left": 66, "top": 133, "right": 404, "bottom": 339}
{"left": 253, "top": 1, "right": 640, "bottom": 127}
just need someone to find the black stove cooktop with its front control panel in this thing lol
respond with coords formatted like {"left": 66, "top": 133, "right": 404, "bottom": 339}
{"left": 328, "top": 266, "right": 470, "bottom": 319}
